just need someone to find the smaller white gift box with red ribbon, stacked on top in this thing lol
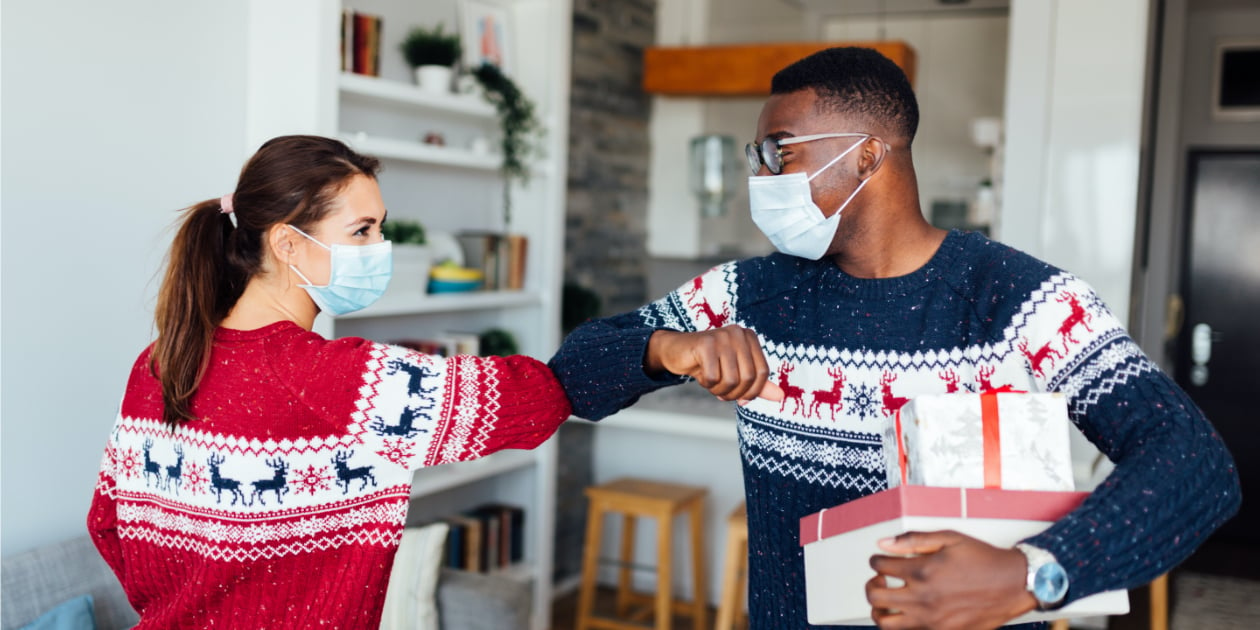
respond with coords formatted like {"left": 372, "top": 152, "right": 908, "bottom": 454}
{"left": 883, "top": 392, "right": 1075, "bottom": 491}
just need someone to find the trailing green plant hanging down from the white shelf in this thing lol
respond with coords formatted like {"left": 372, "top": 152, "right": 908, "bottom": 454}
{"left": 473, "top": 63, "right": 546, "bottom": 222}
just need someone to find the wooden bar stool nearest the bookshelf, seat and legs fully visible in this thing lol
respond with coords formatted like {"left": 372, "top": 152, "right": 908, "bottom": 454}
{"left": 577, "top": 479, "right": 708, "bottom": 630}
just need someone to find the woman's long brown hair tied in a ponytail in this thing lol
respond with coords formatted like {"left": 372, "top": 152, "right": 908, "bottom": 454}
{"left": 149, "top": 136, "right": 381, "bottom": 428}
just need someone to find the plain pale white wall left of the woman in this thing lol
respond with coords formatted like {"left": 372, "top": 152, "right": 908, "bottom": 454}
{"left": 0, "top": 0, "right": 252, "bottom": 556}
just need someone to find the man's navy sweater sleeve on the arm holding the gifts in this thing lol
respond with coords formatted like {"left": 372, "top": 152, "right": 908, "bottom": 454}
{"left": 1017, "top": 275, "right": 1241, "bottom": 601}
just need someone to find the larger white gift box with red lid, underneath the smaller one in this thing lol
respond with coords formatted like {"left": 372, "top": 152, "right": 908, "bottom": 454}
{"left": 800, "top": 485, "right": 1129, "bottom": 625}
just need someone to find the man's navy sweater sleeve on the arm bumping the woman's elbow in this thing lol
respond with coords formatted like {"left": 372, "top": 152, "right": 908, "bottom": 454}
{"left": 548, "top": 262, "right": 736, "bottom": 420}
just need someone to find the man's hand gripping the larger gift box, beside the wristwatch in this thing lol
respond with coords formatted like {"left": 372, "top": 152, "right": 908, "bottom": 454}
{"left": 867, "top": 532, "right": 1037, "bottom": 630}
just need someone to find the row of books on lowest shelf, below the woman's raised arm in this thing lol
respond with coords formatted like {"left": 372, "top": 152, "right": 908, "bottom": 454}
{"left": 442, "top": 503, "right": 525, "bottom": 573}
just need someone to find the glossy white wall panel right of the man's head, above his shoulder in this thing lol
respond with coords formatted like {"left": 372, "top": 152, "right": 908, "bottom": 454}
{"left": 998, "top": 0, "right": 1149, "bottom": 321}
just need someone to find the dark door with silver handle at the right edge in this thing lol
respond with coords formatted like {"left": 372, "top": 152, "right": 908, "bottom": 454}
{"left": 1176, "top": 151, "right": 1260, "bottom": 547}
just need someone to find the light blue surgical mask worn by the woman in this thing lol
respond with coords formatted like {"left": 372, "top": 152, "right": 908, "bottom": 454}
{"left": 289, "top": 226, "right": 393, "bottom": 315}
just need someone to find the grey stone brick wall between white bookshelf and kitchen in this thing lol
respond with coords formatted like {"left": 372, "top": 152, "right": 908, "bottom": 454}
{"left": 553, "top": 0, "right": 656, "bottom": 581}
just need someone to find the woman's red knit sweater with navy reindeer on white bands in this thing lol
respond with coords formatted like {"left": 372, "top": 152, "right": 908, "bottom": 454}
{"left": 87, "top": 321, "right": 570, "bottom": 630}
